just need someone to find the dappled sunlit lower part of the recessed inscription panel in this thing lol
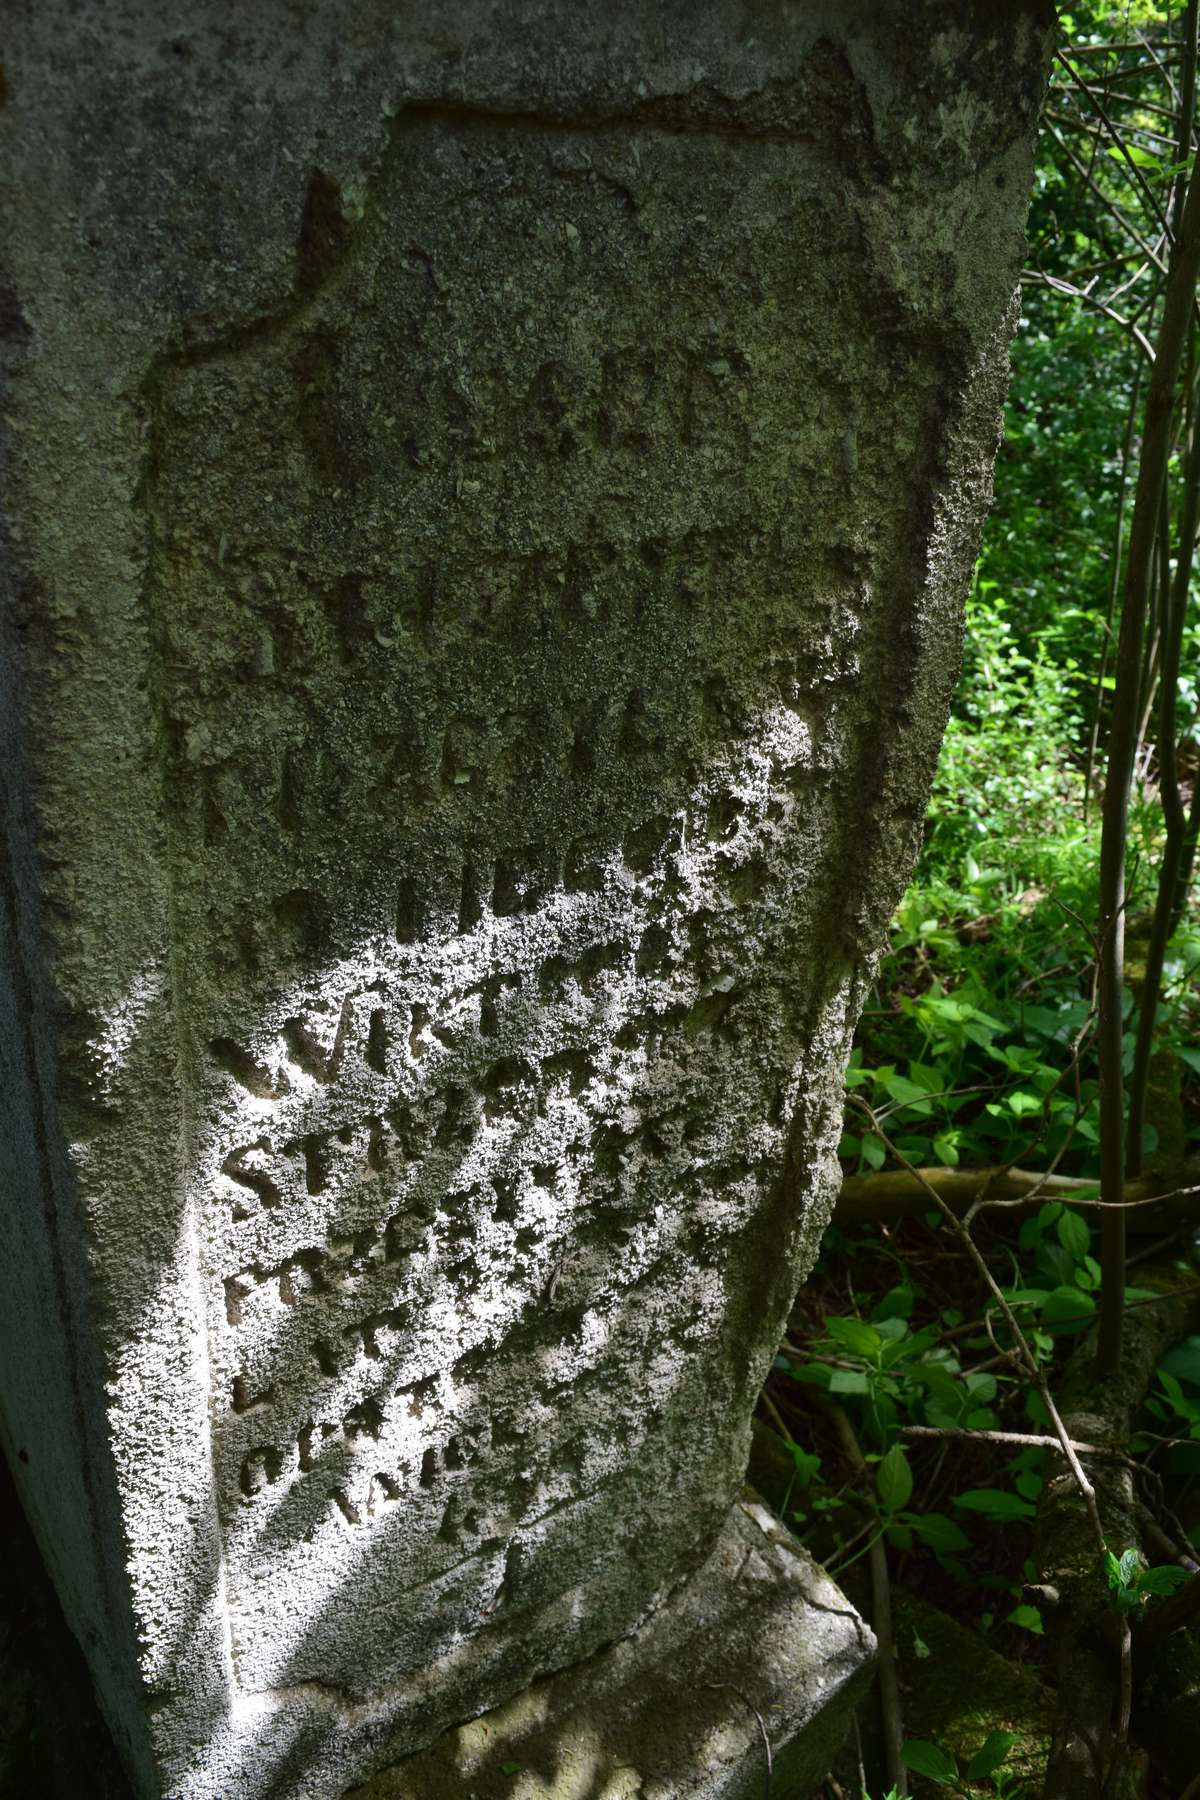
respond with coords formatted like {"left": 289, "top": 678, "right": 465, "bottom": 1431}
{"left": 193, "top": 680, "right": 845, "bottom": 1690}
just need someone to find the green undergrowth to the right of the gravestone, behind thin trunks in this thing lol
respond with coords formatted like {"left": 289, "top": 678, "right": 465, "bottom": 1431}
{"left": 752, "top": 0, "right": 1200, "bottom": 1800}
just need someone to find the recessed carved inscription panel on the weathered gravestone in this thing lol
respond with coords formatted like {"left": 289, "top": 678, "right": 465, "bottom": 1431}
{"left": 141, "top": 117, "right": 934, "bottom": 1685}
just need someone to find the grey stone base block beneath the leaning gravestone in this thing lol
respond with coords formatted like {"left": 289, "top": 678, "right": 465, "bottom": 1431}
{"left": 345, "top": 1494, "right": 874, "bottom": 1800}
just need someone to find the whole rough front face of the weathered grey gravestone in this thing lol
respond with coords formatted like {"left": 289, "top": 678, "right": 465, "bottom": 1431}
{"left": 0, "top": 0, "right": 1051, "bottom": 1800}
